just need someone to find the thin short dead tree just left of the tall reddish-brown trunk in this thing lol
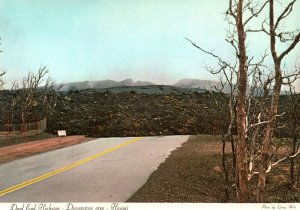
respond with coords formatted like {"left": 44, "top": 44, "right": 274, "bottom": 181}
{"left": 209, "top": 79, "right": 236, "bottom": 202}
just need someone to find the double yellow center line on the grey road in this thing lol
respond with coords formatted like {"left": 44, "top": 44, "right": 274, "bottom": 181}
{"left": 0, "top": 137, "right": 143, "bottom": 196}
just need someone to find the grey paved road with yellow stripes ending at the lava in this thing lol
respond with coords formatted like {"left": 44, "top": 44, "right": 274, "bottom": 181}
{"left": 0, "top": 136, "right": 189, "bottom": 202}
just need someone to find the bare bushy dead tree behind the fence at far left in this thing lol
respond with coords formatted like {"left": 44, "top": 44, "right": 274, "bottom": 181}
{"left": 6, "top": 67, "right": 61, "bottom": 131}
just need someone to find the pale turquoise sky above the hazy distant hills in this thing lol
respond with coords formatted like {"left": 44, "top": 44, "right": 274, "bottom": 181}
{"left": 0, "top": 0, "right": 300, "bottom": 88}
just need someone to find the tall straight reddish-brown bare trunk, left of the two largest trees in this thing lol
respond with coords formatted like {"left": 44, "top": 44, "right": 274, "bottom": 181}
{"left": 236, "top": 0, "right": 249, "bottom": 202}
